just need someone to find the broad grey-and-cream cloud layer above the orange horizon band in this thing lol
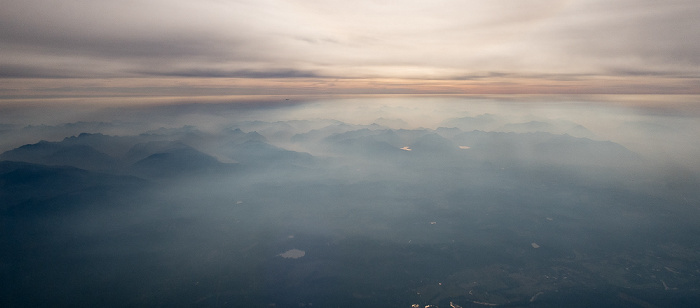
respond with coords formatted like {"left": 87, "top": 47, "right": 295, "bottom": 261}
{"left": 0, "top": 0, "right": 700, "bottom": 80}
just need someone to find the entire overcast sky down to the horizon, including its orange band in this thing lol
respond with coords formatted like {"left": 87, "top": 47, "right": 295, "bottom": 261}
{"left": 0, "top": 0, "right": 700, "bottom": 101}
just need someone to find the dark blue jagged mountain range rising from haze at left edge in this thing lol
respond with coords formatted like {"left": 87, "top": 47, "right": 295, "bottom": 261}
{"left": 0, "top": 128, "right": 246, "bottom": 178}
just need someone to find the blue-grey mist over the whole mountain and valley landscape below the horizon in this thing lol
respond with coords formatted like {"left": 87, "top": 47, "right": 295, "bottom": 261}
{"left": 0, "top": 96, "right": 700, "bottom": 307}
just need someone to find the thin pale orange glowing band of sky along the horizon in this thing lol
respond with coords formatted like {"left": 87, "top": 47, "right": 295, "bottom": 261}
{"left": 0, "top": 76, "right": 700, "bottom": 102}
